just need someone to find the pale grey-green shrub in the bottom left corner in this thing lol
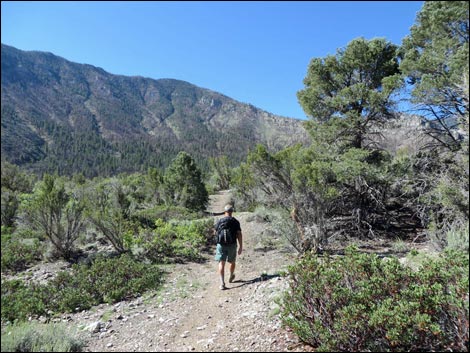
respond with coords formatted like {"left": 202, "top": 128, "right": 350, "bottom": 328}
{"left": 2, "top": 322, "right": 85, "bottom": 352}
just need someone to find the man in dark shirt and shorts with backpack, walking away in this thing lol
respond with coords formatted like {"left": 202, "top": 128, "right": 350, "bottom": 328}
{"left": 215, "top": 205, "right": 243, "bottom": 289}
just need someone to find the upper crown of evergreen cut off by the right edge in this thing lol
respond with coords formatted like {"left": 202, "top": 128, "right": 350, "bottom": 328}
{"left": 400, "top": 1, "right": 469, "bottom": 150}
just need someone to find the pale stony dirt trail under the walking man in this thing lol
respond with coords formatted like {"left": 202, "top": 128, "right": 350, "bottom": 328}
{"left": 72, "top": 191, "right": 308, "bottom": 352}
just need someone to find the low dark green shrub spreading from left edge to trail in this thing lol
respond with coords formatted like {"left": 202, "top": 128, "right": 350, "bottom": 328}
{"left": 2, "top": 255, "right": 162, "bottom": 322}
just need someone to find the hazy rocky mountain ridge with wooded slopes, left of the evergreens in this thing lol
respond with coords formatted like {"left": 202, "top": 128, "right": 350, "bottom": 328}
{"left": 1, "top": 44, "right": 308, "bottom": 177}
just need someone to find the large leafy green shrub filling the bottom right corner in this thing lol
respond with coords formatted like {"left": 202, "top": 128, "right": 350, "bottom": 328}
{"left": 281, "top": 248, "right": 469, "bottom": 352}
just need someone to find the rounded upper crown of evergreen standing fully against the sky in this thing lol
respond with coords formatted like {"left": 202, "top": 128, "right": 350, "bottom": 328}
{"left": 297, "top": 38, "right": 400, "bottom": 148}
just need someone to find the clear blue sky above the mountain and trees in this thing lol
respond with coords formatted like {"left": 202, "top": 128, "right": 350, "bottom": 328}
{"left": 1, "top": 1, "right": 424, "bottom": 119}
